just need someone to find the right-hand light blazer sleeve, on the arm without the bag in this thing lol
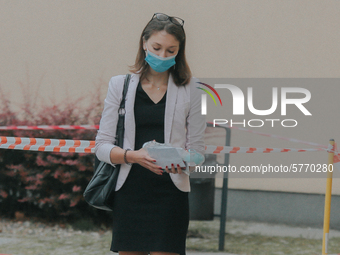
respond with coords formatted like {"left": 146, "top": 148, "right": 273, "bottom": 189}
{"left": 185, "top": 78, "right": 207, "bottom": 161}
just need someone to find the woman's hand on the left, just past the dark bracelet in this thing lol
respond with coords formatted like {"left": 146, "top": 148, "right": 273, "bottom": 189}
{"left": 126, "top": 148, "right": 163, "bottom": 175}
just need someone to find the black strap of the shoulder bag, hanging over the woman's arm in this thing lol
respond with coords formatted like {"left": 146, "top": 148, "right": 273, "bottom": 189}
{"left": 115, "top": 74, "right": 131, "bottom": 148}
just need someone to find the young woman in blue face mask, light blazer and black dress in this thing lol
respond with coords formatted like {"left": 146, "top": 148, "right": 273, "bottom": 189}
{"left": 96, "top": 13, "right": 206, "bottom": 255}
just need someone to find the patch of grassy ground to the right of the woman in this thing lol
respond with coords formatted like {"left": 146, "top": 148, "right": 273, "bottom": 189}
{"left": 187, "top": 220, "right": 340, "bottom": 255}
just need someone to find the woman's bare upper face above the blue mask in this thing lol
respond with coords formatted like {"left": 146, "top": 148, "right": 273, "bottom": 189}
{"left": 143, "top": 30, "right": 179, "bottom": 58}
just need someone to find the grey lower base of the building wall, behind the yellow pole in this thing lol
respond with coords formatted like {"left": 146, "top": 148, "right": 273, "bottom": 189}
{"left": 214, "top": 189, "right": 340, "bottom": 230}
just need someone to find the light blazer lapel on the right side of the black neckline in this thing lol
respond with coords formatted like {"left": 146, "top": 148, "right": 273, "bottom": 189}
{"left": 164, "top": 74, "right": 178, "bottom": 143}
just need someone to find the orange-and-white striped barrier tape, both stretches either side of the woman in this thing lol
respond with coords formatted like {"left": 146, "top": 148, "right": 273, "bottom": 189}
{"left": 0, "top": 136, "right": 325, "bottom": 154}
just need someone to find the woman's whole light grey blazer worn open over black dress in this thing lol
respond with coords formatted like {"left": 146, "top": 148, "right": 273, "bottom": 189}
{"left": 95, "top": 74, "right": 206, "bottom": 192}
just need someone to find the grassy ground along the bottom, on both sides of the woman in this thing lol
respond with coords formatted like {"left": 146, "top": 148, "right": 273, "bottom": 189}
{"left": 0, "top": 220, "right": 340, "bottom": 255}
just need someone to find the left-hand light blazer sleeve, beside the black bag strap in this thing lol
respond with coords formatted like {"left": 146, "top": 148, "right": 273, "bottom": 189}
{"left": 95, "top": 75, "right": 124, "bottom": 166}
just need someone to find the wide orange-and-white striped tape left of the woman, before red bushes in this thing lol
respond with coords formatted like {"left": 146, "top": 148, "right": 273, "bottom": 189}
{"left": 0, "top": 136, "right": 95, "bottom": 153}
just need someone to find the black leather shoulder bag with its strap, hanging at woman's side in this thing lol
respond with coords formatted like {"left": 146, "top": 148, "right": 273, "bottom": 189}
{"left": 84, "top": 74, "right": 131, "bottom": 211}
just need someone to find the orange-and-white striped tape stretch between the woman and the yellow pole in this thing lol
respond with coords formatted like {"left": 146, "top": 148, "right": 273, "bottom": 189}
{"left": 205, "top": 145, "right": 325, "bottom": 154}
